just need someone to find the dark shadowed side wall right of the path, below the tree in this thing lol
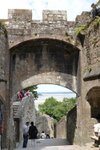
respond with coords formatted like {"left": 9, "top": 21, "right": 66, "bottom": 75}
{"left": 66, "top": 106, "right": 77, "bottom": 144}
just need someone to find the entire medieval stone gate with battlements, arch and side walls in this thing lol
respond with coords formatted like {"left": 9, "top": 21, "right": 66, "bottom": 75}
{"left": 0, "top": 7, "right": 100, "bottom": 147}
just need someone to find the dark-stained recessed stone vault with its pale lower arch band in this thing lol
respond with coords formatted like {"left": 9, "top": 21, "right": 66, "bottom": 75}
{"left": 10, "top": 38, "right": 80, "bottom": 95}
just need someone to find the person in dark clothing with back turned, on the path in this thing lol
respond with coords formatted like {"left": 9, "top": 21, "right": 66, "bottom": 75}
{"left": 29, "top": 122, "right": 38, "bottom": 145}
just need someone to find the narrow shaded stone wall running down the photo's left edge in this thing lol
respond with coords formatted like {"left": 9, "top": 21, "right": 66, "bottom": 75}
{"left": 0, "top": 23, "right": 10, "bottom": 148}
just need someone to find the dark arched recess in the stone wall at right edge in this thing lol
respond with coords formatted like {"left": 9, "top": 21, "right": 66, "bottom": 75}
{"left": 86, "top": 86, "right": 100, "bottom": 118}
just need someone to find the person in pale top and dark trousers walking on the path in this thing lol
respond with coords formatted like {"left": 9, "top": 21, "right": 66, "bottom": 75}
{"left": 23, "top": 122, "right": 29, "bottom": 148}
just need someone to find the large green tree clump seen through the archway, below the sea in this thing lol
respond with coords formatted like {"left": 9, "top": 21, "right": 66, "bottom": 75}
{"left": 39, "top": 97, "right": 76, "bottom": 121}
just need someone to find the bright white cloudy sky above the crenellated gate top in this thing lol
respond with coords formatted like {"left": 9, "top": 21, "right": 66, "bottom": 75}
{"left": 0, "top": 0, "right": 98, "bottom": 21}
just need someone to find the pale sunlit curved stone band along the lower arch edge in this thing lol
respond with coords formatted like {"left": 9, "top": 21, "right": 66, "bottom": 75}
{"left": 21, "top": 72, "right": 77, "bottom": 94}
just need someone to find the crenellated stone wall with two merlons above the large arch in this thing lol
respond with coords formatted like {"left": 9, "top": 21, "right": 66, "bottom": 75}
{"left": 7, "top": 9, "right": 75, "bottom": 47}
